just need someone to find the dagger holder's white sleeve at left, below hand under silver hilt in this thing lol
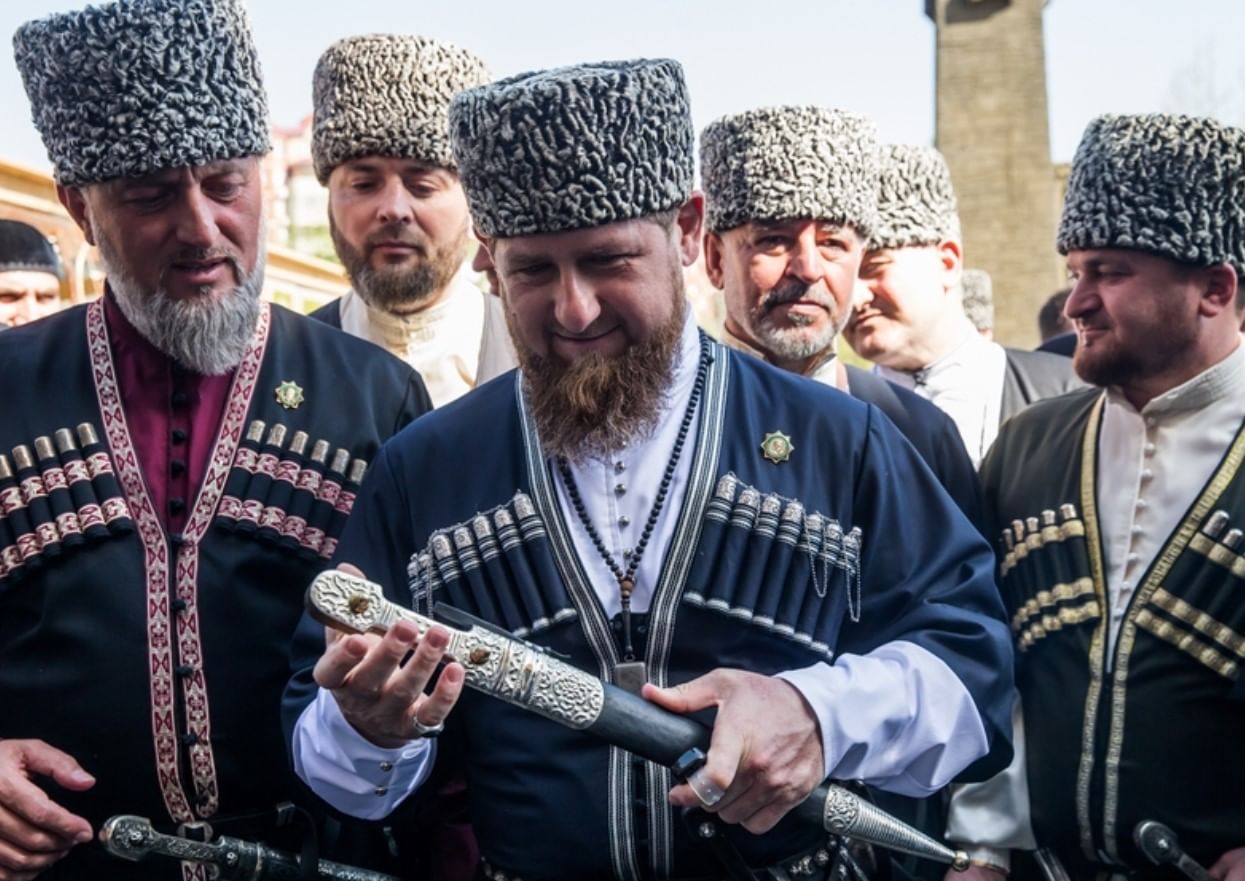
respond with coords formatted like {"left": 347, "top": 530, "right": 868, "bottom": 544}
{"left": 293, "top": 688, "right": 437, "bottom": 820}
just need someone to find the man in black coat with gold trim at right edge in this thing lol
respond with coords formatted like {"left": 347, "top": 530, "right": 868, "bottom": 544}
{"left": 947, "top": 113, "right": 1245, "bottom": 881}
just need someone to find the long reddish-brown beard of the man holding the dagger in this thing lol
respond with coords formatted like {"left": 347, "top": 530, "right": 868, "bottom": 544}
{"left": 505, "top": 268, "right": 687, "bottom": 462}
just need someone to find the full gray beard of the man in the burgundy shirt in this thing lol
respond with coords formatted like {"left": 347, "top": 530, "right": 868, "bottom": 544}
{"left": 98, "top": 230, "right": 268, "bottom": 376}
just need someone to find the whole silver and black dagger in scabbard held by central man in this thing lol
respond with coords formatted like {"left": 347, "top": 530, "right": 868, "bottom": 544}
{"left": 306, "top": 570, "right": 969, "bottom": 871}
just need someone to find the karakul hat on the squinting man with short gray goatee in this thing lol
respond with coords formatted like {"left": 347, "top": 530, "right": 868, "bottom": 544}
{"left": 701, "top": 107, "right": 879, "bottom": 239}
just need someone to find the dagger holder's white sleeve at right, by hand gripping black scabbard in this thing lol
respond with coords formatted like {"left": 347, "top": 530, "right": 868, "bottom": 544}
{"left": 778, "top": 641, "right": 990, "bottom": 798}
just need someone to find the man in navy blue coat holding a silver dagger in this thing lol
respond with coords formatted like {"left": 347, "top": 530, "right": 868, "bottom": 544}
{"left": 285, "top": 58, "right": 1011, "bottom": 881}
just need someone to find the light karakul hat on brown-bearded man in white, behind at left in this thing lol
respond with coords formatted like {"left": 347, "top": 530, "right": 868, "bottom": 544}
{"left": 311, "top": 34, "right": 489, "bottom": 183}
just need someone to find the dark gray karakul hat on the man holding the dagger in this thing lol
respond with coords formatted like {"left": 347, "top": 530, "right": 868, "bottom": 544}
{"left": 449, "top": 58, "right": 693, "bottom": 238}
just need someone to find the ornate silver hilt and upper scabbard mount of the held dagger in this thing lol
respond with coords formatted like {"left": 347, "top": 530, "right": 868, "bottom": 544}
{"left": 306, "top": 570, "right": 605, "bottom": 730}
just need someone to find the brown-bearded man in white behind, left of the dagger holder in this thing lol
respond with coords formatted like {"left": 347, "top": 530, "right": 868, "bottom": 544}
{"left": 311, "top": 34, "right": 514, "bottom": 407}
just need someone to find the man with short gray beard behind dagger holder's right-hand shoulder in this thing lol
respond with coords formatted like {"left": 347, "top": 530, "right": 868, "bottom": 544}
{"left": 700, "top": 107, "right": 980, "bottom": 523}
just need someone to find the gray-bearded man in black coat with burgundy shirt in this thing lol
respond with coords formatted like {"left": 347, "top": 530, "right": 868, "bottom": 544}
{"left": 0, "top": 0, "right": 430, "bottom": 881}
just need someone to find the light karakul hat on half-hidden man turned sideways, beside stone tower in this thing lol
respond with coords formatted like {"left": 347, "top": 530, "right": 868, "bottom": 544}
{"left": 869, "top": 144, "right": 960, "bottom": 249}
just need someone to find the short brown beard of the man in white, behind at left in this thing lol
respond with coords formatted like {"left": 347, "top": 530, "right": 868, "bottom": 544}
{"left": 329, "top": 213, "right": 469, "bottom": 315}
